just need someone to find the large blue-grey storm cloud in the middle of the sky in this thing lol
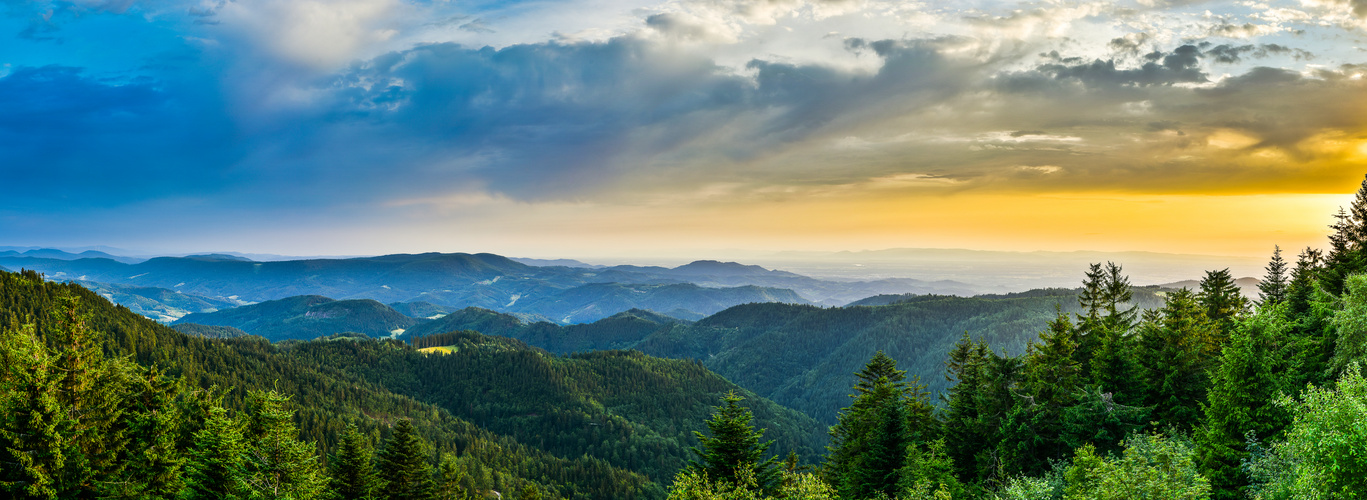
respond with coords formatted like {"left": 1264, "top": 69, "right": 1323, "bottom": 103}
{"left": 319, "top": 36, "right": 972, "bottom": 199}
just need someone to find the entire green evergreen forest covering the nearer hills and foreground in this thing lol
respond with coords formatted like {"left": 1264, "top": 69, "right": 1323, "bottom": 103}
{"left": 13, "top": 177, "right": 1367, "bottom": 500}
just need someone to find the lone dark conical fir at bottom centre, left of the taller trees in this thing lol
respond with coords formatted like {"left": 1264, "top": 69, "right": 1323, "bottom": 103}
{"left": 690, "top": 391, "right": 779, "bottom": 489}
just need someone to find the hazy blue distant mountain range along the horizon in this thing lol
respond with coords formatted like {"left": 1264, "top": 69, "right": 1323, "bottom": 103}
{"left": 0, "top": 250, "right": 977, "bottom": 324}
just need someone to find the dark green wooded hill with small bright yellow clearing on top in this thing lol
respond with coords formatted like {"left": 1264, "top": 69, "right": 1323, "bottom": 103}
{"left": 287, "top": 332, "right": 824, "bottom": 481}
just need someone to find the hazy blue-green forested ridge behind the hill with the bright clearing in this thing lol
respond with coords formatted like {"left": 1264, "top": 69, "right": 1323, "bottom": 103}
{"left": 409, "top": 287, "right": 1162, "bottom": 423}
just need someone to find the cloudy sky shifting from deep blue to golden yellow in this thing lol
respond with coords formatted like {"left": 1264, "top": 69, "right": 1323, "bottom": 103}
{"left": 8, "top": 0, "right": 1367, "bottom": 258}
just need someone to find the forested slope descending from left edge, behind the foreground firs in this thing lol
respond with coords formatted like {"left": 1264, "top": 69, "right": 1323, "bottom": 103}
{"left": 0, "top": 273, "right": 663, "bottom": 499}
